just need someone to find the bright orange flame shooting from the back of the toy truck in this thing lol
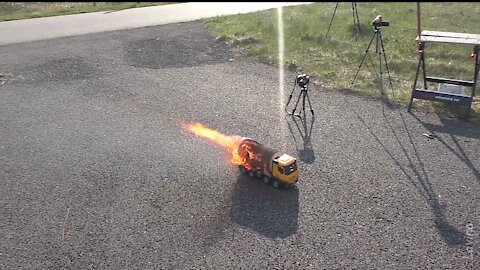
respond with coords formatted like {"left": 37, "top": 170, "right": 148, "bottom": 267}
{"left": 182, "top": 123, "right": 251, "bottom": 169}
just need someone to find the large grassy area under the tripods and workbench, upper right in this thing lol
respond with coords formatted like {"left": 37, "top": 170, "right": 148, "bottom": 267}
{"left": 205, "top": 2, "right": 480, "bottom": 120}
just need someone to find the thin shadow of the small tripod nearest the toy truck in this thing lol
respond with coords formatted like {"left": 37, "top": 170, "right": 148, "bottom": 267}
{"left": 286, "top": 114, "right": 315, "bottom": 164}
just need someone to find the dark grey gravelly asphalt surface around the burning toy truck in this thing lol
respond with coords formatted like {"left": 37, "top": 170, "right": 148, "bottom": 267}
{"left": 0, "top": 22, "right": 480, "bottom": 269}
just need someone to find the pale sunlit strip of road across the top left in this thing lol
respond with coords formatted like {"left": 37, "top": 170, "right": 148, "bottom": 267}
{"left": 0, "top": 2, "right": 307, "bottom": 45}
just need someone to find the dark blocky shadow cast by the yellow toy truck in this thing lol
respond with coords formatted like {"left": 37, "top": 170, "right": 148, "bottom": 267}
{"left": 230, "top": 175, "right": 299, "bottom": 239}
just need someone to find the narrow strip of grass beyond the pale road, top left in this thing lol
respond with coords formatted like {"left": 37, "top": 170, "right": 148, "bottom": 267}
{"left": 0, "top": 2, "right": 178, "bottom": 21}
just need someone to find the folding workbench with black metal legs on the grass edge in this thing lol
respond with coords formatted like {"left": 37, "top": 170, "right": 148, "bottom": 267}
{"left": 408, "top": 30, "right": 480, "bottom": 117}
